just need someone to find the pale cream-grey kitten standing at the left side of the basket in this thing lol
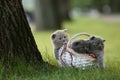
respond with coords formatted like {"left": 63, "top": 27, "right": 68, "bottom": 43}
{"left": 51, "top": 29, "right": 69, "bottom": 60}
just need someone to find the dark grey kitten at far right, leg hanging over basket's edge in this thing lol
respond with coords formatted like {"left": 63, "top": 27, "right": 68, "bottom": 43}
{"left": 88, "top": 36, "right": 105, "bottom": 68}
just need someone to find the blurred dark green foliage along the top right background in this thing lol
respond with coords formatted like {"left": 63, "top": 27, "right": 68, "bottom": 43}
{"left": 71, "top": 0, "right": 120, "bottom": 13}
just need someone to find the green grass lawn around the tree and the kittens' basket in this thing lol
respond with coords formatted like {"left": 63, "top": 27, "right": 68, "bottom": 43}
{"left": 0, "top": 17, "right": 120, "bottom": 80}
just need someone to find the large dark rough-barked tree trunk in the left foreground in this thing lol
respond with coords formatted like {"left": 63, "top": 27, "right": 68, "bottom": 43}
{"left": 0, "top": 0, "right": 43, "bottom": 64}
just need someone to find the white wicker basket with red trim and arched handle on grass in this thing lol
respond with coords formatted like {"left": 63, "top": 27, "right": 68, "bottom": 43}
{"left": 58, "top": 33, "right": 97, "bottom": 69}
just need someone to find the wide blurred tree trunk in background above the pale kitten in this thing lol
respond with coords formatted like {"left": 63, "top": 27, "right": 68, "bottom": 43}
{"left": 35, "top": 0, "right": 69, "bottom": 30}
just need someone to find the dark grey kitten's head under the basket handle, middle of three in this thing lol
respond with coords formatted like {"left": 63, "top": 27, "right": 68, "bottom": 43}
{"left": 72, "top": 40, "right": 89, "bottom": 53}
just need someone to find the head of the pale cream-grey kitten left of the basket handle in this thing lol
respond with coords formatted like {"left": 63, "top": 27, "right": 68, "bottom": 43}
{"left": 51, "top": 30, "right": 69, "bottom": 47}
